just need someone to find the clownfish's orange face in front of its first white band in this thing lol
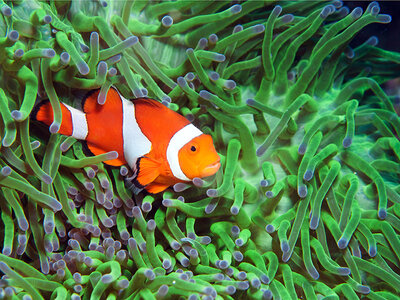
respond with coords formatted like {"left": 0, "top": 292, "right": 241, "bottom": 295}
{"left": 178, "top": 134, "right": 221, "bottom": 179}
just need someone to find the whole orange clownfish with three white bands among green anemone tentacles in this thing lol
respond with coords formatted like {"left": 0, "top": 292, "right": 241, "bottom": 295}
{"left": 32, "top": 88, "right": 220, "bottom": 194}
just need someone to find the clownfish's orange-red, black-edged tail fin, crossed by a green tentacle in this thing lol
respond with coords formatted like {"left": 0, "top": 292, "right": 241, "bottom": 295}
{"left": 31, "top": 100, "right": 73, "bottom": 135}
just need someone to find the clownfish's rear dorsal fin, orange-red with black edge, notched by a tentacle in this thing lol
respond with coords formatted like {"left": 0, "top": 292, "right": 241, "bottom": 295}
{"left": 82, "top": 87, "right": 121, "bottom": 114}
